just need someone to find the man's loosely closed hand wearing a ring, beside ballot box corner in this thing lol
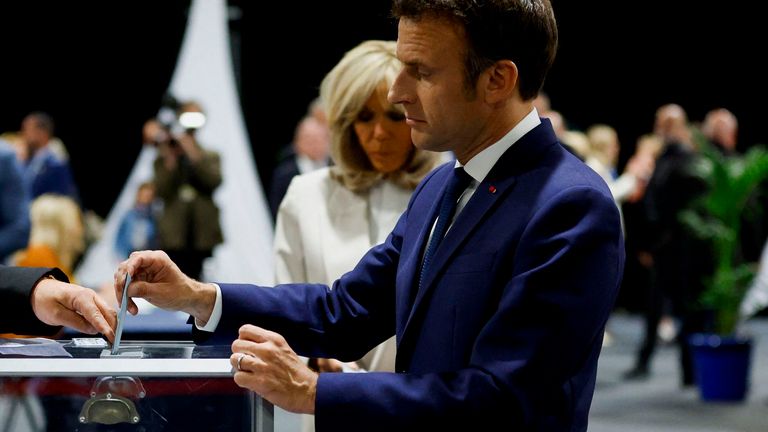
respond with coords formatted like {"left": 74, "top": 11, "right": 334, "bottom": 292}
{"left": 229, "top": 324, "right": 317, "bottom": 414}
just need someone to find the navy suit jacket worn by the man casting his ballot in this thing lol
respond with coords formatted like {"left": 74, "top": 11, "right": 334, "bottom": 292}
{"left": 210, "top": 119, "right": 624, "bottom": 431}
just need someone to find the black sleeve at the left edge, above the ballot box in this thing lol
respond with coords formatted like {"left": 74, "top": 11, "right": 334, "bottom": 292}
{"left": 0, "top": 266, "right": 69, "bottom": 336}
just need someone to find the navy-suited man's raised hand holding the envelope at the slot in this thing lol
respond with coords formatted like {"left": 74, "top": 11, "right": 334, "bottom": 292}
{"left": 115, "top": 251, "right": 216, "bottom": 323}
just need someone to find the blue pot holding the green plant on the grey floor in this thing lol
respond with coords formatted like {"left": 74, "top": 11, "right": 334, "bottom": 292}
{"left": 688, "top": 333, "right": 752, "bottom": 402}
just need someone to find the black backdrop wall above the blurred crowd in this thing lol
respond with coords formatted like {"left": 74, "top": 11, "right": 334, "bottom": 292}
{"left": 0, "top": 0, "right": 768, "bottom": 216}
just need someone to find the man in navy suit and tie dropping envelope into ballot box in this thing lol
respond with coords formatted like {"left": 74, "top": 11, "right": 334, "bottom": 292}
{"left": 115, "top": 0, "right": 624, "bottom": 431}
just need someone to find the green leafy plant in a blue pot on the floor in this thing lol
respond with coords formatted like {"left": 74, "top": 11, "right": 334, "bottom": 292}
{"left": 680, "top": 136, "right": 768, "bottom": 400}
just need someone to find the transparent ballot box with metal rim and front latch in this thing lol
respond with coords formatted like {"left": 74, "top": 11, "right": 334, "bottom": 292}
{"left": 0, "top": 340, "right": 273, "bottom": 432}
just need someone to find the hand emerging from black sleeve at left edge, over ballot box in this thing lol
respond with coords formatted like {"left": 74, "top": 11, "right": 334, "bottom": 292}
{"left": 30, "top": 278, "right": 117, "bottom": 342}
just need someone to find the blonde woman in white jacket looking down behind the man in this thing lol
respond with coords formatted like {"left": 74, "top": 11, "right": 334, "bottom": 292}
{"left": 275, "top": 41, "right": 439, "bottom": 371}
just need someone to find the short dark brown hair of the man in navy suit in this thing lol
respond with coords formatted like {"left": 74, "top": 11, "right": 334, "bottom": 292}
{"left": 392, "top": 0, "right": 557, "bottom": 100}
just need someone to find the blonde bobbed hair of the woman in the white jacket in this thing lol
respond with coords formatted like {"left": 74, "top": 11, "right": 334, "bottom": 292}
{"left": 320, "top": 40, "right": 438, "bottom": 192}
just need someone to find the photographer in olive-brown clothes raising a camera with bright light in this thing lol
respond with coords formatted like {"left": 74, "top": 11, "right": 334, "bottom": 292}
{"left": 144, "top": 102, "right": 223, "bottom": 278}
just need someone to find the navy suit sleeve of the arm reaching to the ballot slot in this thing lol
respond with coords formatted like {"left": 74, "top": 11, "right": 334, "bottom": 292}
{"left": 206, "top": 210, "right": 403, "bottom": 361}
